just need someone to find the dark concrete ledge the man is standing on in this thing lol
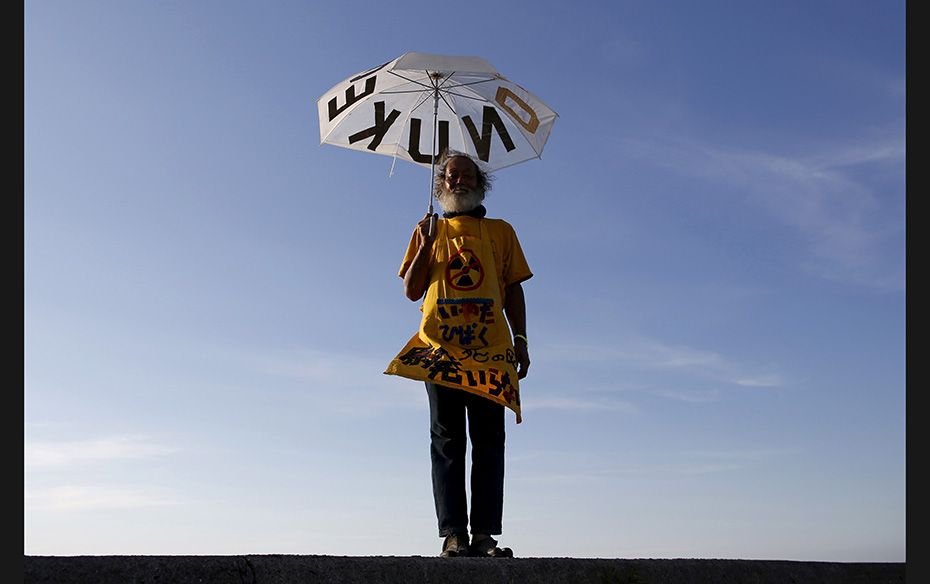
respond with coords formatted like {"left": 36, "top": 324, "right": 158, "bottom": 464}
{"left": 23, "top": 555, "right": 905, "bottom": 584}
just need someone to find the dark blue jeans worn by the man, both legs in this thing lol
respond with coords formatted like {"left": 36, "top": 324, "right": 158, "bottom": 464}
{"left": 426, "top": 382, "right": 504, "bottom": 537}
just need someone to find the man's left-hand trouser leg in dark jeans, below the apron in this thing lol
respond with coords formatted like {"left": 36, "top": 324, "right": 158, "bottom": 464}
{"left": 426, "top": 382, "right": 468, "bottom": 537}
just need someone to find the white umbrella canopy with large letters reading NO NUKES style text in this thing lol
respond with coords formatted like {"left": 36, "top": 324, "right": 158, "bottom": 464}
{"left": 317, "top": 53, "right": 557, "bottom": 171}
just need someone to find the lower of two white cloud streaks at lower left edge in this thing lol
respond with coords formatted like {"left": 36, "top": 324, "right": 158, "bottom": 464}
{"left": 25, "top": 485, "right": 179, "bottom": 511}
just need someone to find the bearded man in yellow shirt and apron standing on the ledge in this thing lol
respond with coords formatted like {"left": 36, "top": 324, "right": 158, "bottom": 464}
{"left": 385, "top": 152, "right": 533, "bottom": 557}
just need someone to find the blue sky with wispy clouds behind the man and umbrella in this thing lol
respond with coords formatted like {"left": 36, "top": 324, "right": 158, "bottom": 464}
{"left": 24, "top": 0, "right": 906, "bottom": 561}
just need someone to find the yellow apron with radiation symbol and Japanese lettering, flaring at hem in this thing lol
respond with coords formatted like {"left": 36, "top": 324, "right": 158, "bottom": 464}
{"left": 385, "top": 219, "right": 522, "bottom": 424}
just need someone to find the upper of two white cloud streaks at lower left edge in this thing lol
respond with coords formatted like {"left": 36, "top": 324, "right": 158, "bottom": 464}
{"left": 25, "top": 435, "right": 177, "bottom": 469}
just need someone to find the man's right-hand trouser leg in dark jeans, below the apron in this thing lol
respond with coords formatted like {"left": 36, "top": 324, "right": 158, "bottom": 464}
{"left": 465, "top": 394, "right": 504, "bottom": 535}
